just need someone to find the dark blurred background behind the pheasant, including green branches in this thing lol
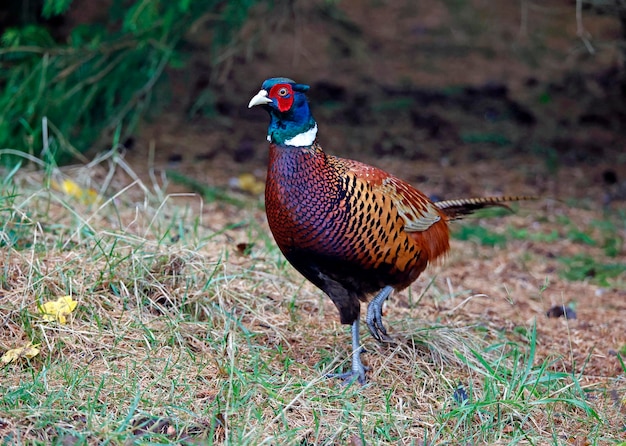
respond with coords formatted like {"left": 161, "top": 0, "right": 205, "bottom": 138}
{"left": 0, "top": 0, "right": 626, "bottom": 204}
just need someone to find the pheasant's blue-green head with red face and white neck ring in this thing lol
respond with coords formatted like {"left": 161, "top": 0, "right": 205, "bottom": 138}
{"left": 248, "top": 77, "right": 317, "bottom": 147}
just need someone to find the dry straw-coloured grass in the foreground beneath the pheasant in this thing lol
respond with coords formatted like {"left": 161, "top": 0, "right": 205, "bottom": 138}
{"left": 0, "top": 154, "right": 625, "bottom": 445}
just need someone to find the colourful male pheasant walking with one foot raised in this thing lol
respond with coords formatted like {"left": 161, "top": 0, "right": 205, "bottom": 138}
{"left": 248, "top": 78, "right": 528, "bottom": 384}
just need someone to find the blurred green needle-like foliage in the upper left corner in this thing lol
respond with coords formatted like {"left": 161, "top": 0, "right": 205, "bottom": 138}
{"left": 0, "top": 0, "right": 261, "bottom": 166}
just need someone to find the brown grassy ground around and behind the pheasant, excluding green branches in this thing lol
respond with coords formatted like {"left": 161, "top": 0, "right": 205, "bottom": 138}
{"left": 0, "top": 0, "right": 626, "bottom": 445}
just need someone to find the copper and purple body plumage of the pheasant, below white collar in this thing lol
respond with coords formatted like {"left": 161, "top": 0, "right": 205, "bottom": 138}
{"left": 265, "top": 144, "right": 449, "bottom": 324}
